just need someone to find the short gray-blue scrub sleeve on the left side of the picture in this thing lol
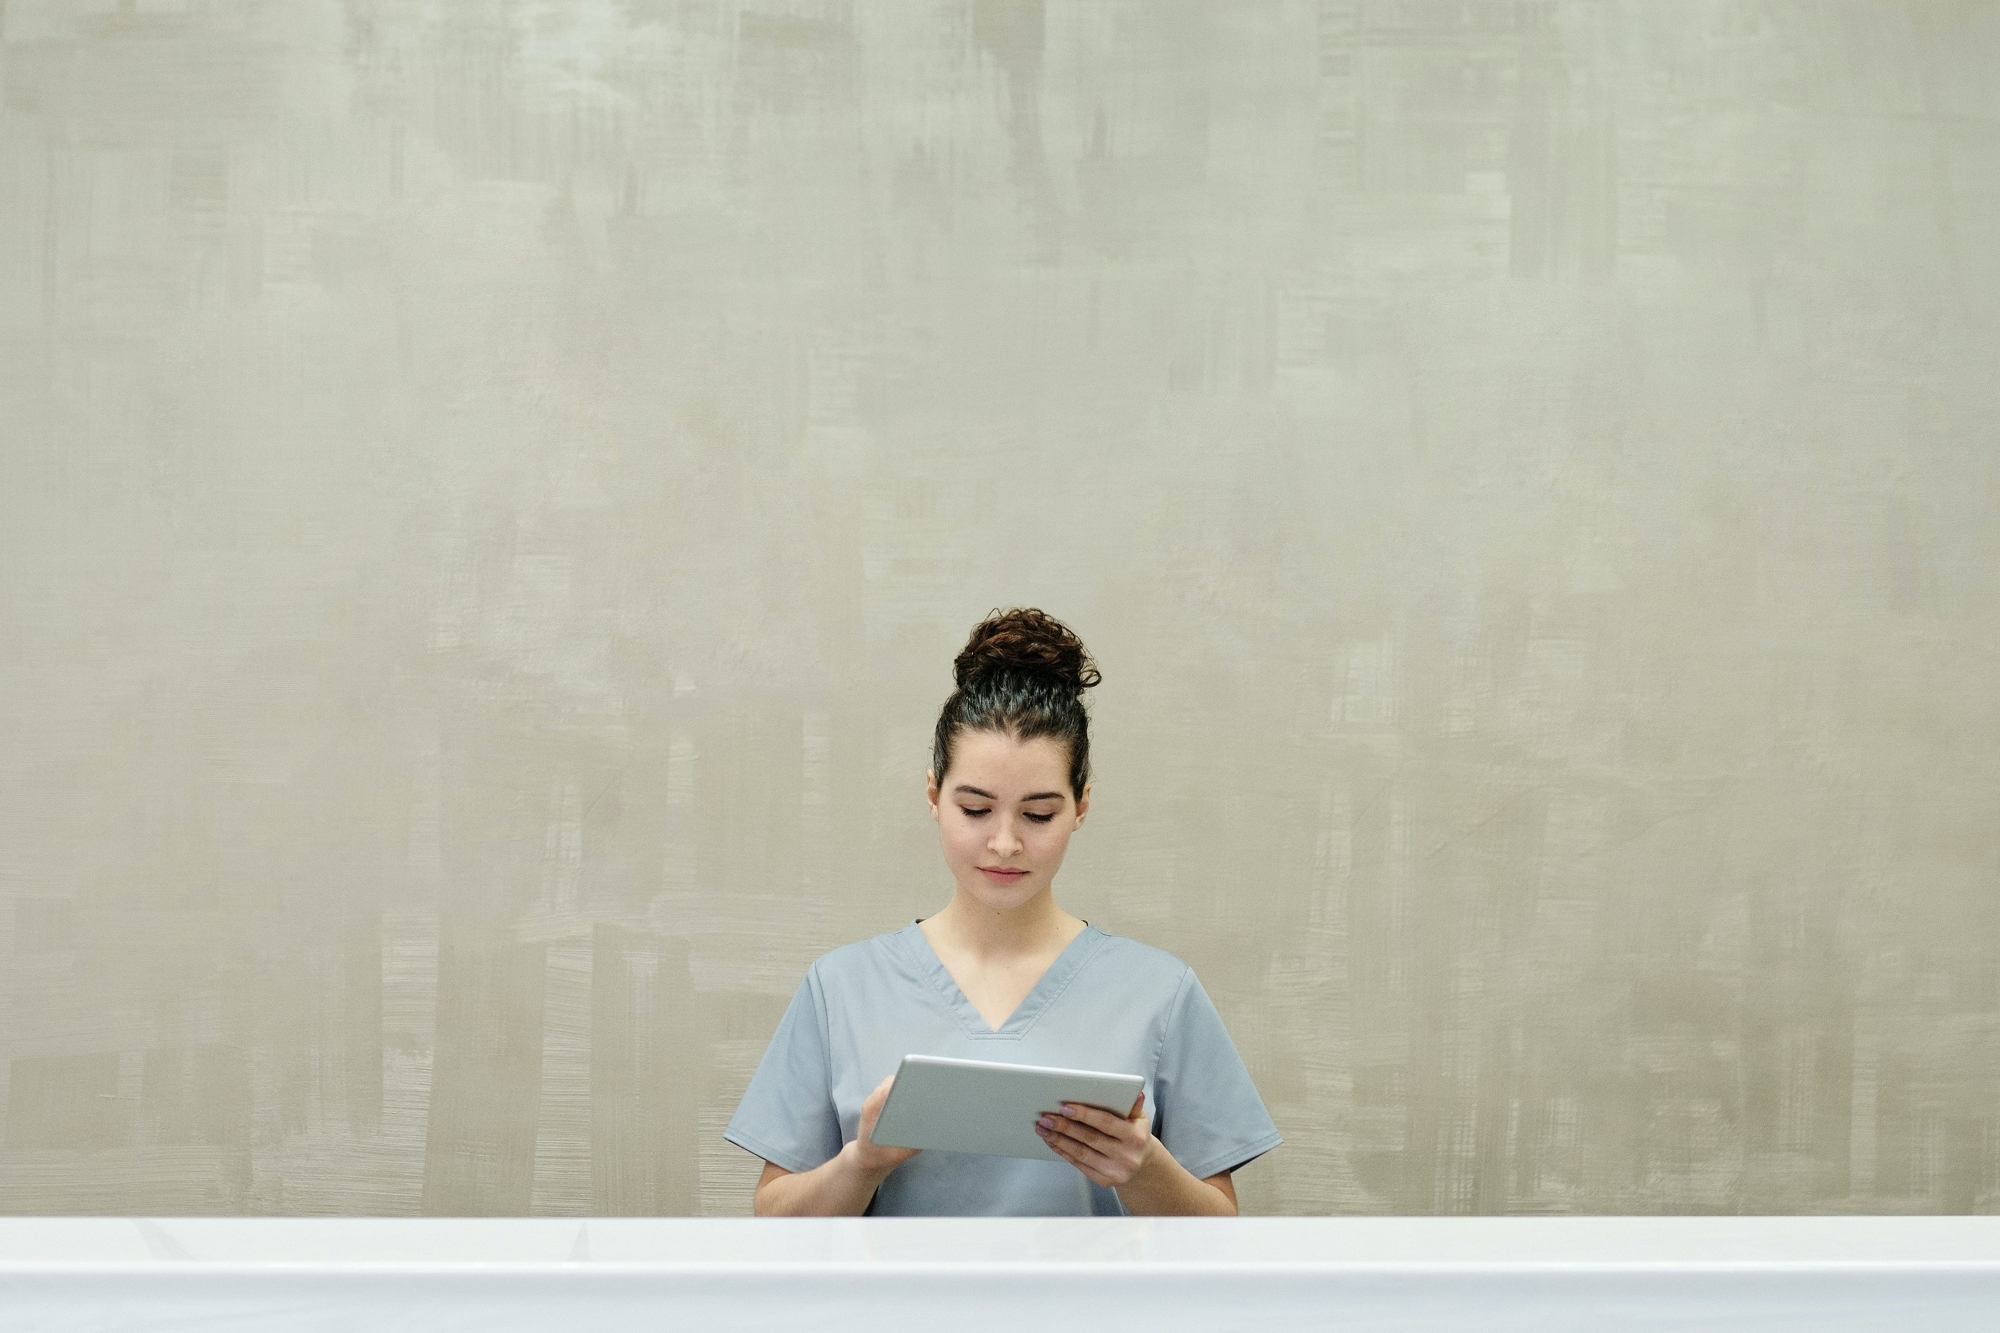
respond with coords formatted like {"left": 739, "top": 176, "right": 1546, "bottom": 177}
{"left": 722, "top": 971, "right": 840, "bottom": 1171}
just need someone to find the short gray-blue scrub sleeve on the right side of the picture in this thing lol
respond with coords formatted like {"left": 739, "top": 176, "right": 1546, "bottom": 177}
{"left": 1154, "top": 969, "right": 1282, "bottom": 1177}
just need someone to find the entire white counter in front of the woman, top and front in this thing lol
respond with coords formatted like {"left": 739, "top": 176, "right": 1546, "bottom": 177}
{"left": 0, "top": 1217, "right": 2000, "bottom": 1333}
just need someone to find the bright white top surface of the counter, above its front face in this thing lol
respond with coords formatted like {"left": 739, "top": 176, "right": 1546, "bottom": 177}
{"left": 0, "top": 1217, "right": 2000, "bottom": 1264}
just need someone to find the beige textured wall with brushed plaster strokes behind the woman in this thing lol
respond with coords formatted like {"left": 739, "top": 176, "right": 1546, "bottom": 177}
{"left": 0, "top": 0, "right": 2000, "bottom": 1213}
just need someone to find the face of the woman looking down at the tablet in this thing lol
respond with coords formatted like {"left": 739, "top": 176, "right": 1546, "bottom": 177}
{"left": 926, "top": 731, "right": 1090, "bottom": 911}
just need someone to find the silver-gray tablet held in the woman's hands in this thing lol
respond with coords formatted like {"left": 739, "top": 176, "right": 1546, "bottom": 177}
{"left": 874, "top": 1055, "right": 1146, "bottom": 1161}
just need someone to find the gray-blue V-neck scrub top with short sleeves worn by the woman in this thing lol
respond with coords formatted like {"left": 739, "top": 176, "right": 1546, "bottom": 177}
{"left": 722, "top": 923, "right": 1280, "bottom": 1217}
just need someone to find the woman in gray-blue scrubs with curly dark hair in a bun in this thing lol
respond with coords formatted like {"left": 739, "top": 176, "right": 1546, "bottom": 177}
{"left": 724, "top": 610, "right": 1278, "bottom": 1215}
